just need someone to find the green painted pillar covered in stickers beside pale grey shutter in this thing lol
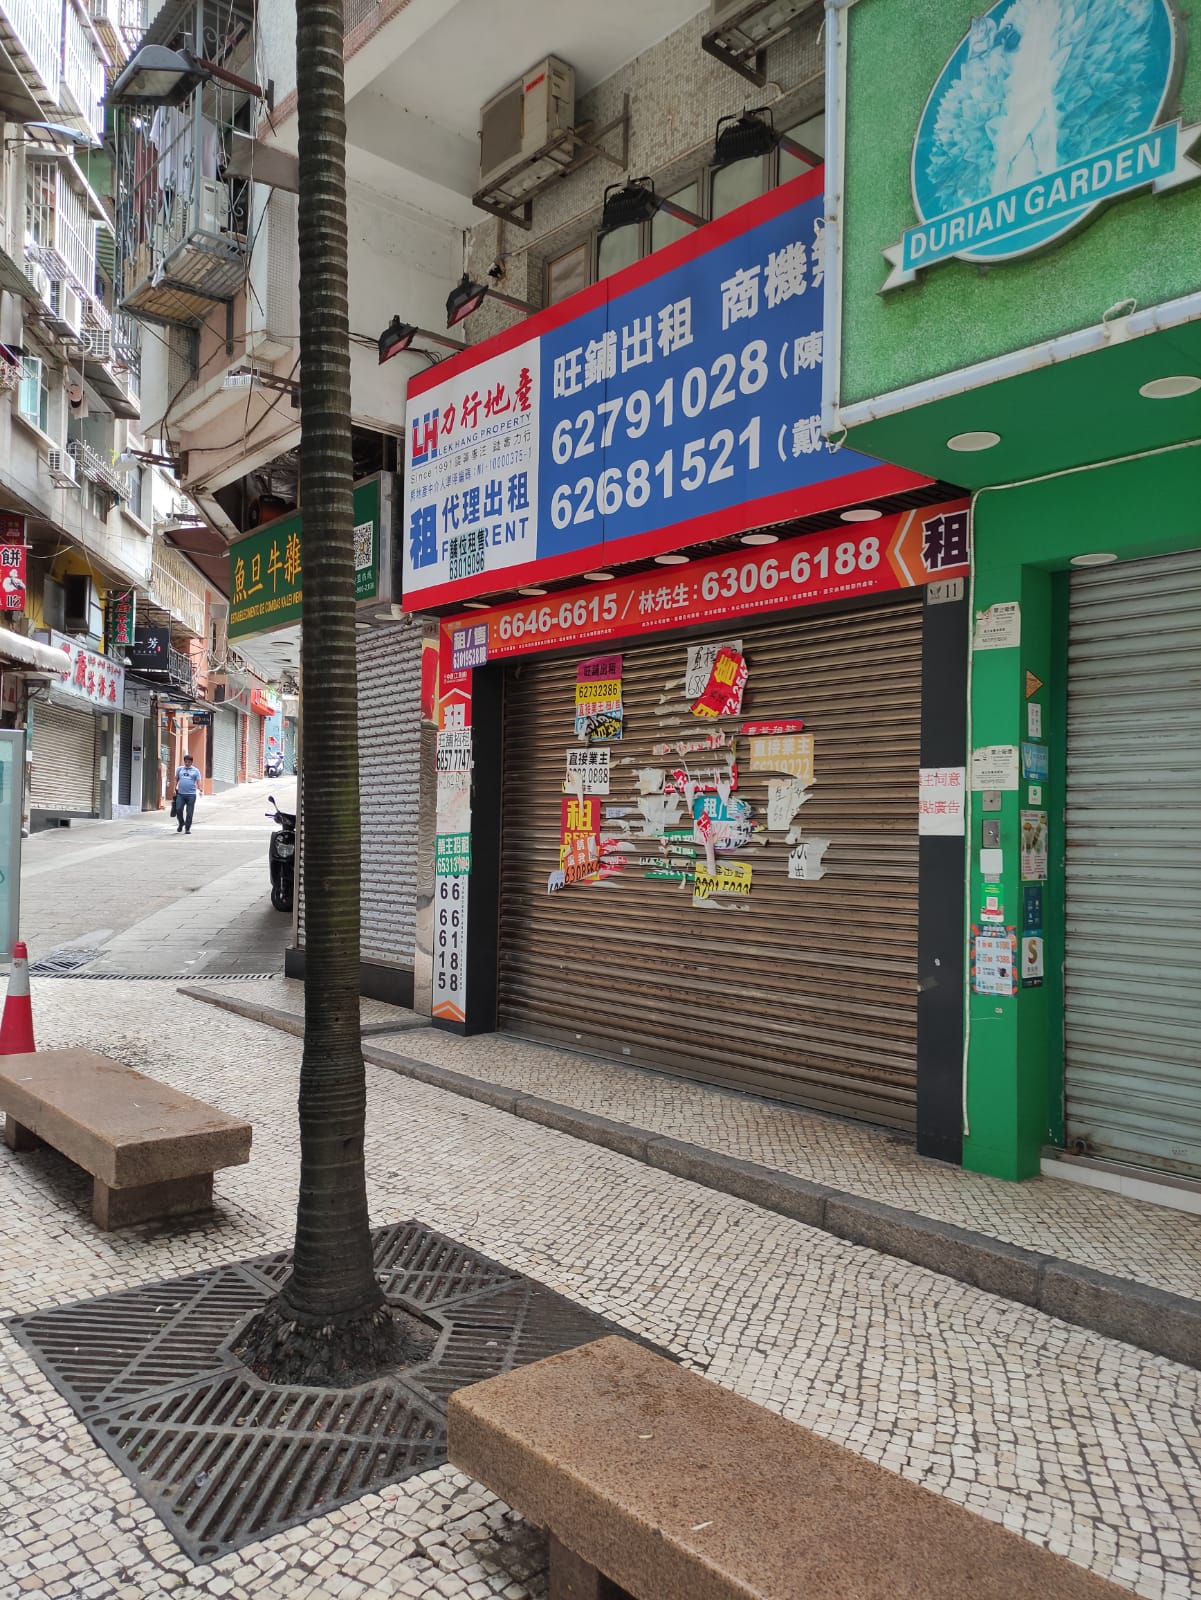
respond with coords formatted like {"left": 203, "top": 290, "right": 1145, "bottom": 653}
{"left": 963, "top": 563, "right": 1062, "bottom": 1179}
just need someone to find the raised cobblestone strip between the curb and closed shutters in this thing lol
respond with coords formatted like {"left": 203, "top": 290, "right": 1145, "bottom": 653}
{"left": 205, "top": 978, "right": 1201, "bottom": 1299}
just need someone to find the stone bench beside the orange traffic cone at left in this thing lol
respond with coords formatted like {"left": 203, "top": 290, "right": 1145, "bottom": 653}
{"left": 0, "top": 1050, "right": 251, "bottom": 1229}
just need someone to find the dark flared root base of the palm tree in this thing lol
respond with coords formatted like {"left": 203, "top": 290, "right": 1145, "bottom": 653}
{"left": 233, "top": 1294, "right": 438, "bottom": 1389}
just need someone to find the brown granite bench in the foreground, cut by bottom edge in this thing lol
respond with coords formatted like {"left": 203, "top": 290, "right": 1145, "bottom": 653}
{"left": 449, "top": 1338, "right": 1129, "bottom": 1600}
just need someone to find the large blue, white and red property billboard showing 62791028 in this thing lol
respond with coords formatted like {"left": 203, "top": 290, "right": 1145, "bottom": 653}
{"left": 405, "top": 173, "right": 928, "bottom": 610}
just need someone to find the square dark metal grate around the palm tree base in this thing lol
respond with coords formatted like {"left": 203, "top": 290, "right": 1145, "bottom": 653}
{"left": 8, "top": 1222, "right": 649, "bottom": 1562}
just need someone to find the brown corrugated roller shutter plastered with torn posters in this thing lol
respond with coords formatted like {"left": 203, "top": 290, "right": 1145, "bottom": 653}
{"left": 499, "top": 598, "right": 921, "bottom": 1128}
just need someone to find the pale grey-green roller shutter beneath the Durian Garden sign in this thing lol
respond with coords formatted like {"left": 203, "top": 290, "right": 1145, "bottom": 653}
{"left": 1065, "top": 550, "right": 1201, "bottom": 1176}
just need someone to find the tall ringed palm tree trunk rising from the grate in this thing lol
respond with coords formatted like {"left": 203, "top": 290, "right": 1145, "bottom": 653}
{"left": 240, "top": 0, "right": 422, "bottom": 1386}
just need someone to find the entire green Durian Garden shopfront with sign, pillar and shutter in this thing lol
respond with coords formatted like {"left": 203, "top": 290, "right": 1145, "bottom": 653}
{"left": 824, "top": 0, "right": 1201, "bottom": 1182}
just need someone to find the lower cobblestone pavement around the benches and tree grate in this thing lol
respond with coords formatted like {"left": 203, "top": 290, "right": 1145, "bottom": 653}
{"left": 0, "top": 979, "right": 1201, "bottom": 1600}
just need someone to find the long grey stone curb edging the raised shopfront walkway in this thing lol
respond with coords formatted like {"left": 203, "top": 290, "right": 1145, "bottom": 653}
{"left": 178, "top": 987, "right": 1201, "bottom": 1368}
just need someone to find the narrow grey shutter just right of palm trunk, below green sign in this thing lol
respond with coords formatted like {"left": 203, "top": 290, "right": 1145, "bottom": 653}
{"left": 297, "top": 626, "right": 421, "bottom": 968}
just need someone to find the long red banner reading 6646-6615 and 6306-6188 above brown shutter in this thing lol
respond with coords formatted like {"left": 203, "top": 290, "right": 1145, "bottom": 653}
{"left": 441, "top": 501, "right": 969, "bottom": 672}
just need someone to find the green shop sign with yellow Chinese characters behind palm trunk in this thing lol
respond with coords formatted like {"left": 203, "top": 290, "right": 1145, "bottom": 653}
{"left": 229, "top": 472, "right": 393, "bottom": 638}
